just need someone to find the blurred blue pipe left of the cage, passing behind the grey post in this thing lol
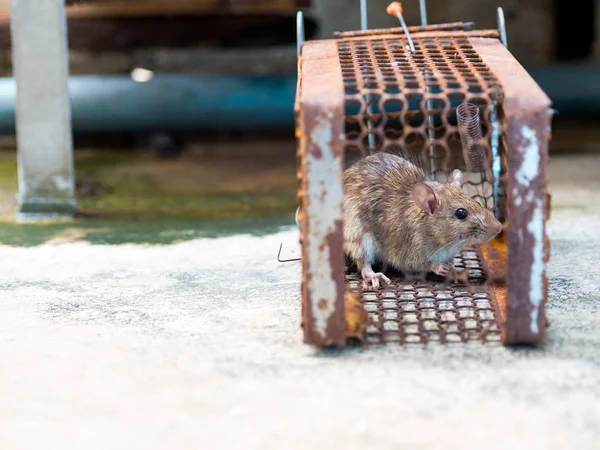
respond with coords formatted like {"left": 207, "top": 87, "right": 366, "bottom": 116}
{"left": 0, "top": 75, "right": 296, "bottom": 134}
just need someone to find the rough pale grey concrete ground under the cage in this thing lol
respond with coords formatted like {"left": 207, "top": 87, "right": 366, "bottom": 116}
{"left": 0, "top": 156, "right": 600, "bottom": 450}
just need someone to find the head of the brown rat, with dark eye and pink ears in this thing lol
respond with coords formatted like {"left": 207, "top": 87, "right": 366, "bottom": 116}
{"left": 412, "top": 170, "right": 502, "bottom": 245}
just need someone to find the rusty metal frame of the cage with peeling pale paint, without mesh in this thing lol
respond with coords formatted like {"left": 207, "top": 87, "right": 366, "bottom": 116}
{"left": 295, "top": 25, "right": 552, "bottom": 347}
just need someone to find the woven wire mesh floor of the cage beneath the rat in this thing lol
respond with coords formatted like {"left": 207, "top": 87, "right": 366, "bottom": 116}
{"left": 346, "top": 249, "right": 501, "bottom": 344}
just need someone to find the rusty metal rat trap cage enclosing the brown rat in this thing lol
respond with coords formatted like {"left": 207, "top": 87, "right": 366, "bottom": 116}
{"left": 295, "top": 12, "right": 552, "bottom": 347}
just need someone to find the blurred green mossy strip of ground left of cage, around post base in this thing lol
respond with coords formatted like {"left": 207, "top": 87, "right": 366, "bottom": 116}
{"left": 0, "top": 146, "right": 296, "bottom": 246}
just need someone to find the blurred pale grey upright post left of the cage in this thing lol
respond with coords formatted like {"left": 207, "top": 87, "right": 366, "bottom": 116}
{"left": 11, "top": 0, "right": 76, "bottom": 219}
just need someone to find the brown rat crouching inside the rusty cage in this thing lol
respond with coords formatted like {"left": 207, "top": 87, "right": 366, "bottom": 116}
{"left": 343, "top": 152, "right": 502, "bottom": 290}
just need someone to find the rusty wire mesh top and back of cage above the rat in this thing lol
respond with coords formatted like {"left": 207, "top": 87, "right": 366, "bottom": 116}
{"left": 338, "top": 36, "right": 502, "bottom": 208}
